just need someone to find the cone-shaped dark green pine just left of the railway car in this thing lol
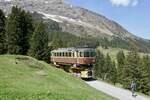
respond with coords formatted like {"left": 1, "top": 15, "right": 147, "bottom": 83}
{"left": 28, "top": 22, "right": 49, "bottom": 60}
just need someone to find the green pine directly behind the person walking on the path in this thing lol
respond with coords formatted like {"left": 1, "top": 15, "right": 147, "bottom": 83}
{"left": 123, "top": 50, "right": 141, "bottom": 89}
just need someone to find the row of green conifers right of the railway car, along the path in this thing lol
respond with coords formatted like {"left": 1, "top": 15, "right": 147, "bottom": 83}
{"left": 94, "top": 50, "right": 150, "bottom": 95}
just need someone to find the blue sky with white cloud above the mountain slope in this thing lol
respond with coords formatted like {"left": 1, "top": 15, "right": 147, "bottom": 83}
{"left": 65, "top": 0, "right": 150, "bottom": 39}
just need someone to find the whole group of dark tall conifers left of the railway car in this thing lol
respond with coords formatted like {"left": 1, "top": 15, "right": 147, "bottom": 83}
{"left": 0, "top": 6, "right": 48, "bottom": 60}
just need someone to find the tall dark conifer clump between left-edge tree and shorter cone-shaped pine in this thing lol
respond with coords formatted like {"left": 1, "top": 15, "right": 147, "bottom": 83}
{"left": 6, "top": 7, "right": 33, "bottom": 54}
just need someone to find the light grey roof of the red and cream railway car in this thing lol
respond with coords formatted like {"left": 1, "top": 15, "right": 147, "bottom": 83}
{"left": 51, "top": 48, "right": 95, "bottom": 52}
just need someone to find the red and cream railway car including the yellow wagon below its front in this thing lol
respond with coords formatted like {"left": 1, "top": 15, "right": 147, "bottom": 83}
{"left": 51, "top": 48, "right": 96, "bottom": 78}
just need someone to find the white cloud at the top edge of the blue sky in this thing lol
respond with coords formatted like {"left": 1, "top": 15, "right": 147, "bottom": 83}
{"left": 110, "top": 0, "right": 139, "bottom": 6}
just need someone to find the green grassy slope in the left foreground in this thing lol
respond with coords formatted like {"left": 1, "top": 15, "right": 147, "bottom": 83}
{"left": 0, "top": 55, "right": 114, "bottom": 100}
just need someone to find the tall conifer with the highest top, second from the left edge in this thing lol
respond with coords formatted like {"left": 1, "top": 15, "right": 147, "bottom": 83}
{"left": 6, "top": 7, "right": 21, "bottom": 54}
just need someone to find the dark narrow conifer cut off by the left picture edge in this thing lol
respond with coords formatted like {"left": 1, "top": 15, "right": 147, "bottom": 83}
{"left": 0, "top": 9, "right": 6, "bottom": 54}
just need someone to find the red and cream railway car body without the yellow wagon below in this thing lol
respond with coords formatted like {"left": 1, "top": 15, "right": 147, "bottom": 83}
{"left": 51, "top": 48, "right": 95, "bottom": 65}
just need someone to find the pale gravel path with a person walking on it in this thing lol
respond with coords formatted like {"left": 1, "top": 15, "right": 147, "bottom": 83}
{"left": 86, "top": 81, "right": 150, "bottom": 100}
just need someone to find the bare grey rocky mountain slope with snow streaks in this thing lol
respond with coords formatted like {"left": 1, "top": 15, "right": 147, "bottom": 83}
{"left": 0, "top": 0, "right": 150, "bottom": 52}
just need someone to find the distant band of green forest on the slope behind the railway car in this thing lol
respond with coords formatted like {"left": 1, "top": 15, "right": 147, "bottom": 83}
{"left": 48, "top": 31, "right": 150, "bottom": 52}
